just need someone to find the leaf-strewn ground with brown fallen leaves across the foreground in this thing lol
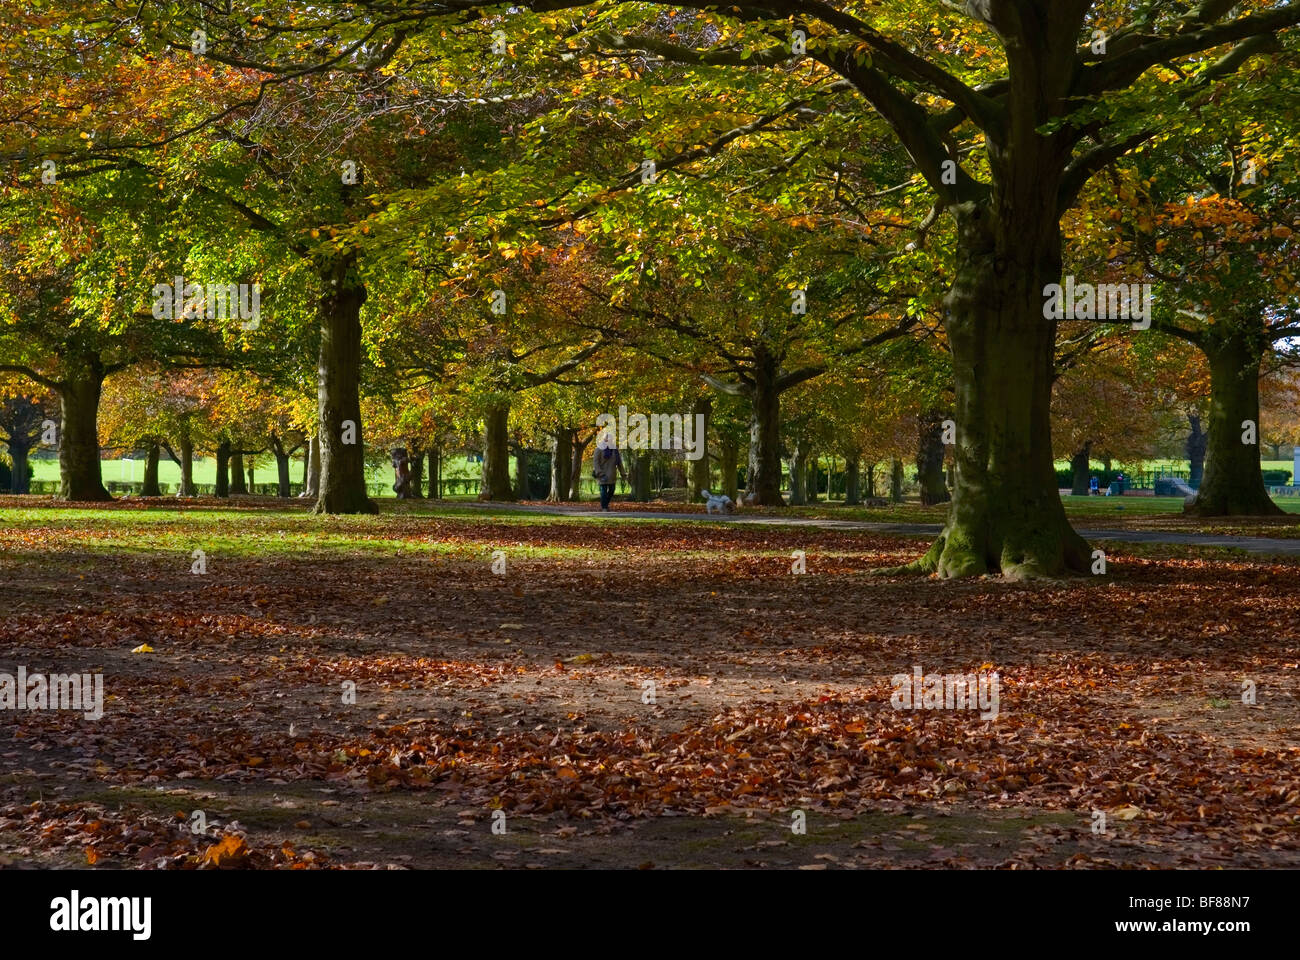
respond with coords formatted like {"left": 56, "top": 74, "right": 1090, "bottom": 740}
{"left": 0, "top": 507, "right": 1300, "bottom": 869}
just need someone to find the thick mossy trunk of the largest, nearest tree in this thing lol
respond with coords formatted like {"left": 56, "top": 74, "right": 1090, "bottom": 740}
{"left": 910, "top": 201, "right": 1092, "bottom": 579}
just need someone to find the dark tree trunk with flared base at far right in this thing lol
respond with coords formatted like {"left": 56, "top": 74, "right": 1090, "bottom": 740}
{"left": 1183, "top": 334, "right": 1284, "bottom": 516}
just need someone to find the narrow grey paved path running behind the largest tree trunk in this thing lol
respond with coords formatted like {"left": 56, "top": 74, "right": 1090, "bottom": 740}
{"left": 458, "top": 503, "right": 1300, "bottom": 557}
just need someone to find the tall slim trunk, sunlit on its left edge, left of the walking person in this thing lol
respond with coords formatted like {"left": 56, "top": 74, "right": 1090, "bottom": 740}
{"left": 315, "top": 251, "right": 380, "bottom": 514}
